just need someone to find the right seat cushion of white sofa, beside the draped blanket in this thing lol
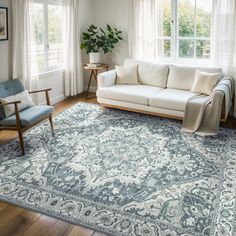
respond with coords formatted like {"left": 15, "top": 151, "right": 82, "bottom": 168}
{"left": 150, "top": 89, "right": 199, "bottom": 111}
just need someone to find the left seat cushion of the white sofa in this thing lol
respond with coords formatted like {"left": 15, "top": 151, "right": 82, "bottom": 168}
{"left": 97, "top": 85, "right": 163, "bottom": 105}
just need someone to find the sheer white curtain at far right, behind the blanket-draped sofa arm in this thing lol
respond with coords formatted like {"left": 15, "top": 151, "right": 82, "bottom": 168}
{"left": 212, "top": 0, "right": 236, "bottom": 117}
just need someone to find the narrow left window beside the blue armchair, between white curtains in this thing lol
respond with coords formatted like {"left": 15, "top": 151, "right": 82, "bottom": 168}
{"left": 33, "top": 0, "right": 63, "bottom": 73}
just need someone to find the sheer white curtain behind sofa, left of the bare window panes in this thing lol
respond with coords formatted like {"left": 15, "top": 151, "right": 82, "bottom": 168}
{"left": 129, "top": 0, "right": 164, "bottom": 60}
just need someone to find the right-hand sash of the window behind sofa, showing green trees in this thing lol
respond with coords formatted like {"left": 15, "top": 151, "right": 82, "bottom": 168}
{"left": 177, "top": 0, "right": 212, "bottom": 60}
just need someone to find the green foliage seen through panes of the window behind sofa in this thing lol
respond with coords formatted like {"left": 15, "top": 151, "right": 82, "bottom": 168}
{"left": 163, "top": 0, "right": 211, "bottom": 58}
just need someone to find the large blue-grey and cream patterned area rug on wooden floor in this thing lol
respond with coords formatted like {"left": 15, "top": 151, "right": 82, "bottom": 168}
{"left": 0, "top": 103, "right": 236, "bottom": 236}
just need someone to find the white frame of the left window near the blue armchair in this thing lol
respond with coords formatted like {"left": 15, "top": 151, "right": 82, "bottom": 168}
{"left": 33, "top": 0, "right": 64, "bottom": 75}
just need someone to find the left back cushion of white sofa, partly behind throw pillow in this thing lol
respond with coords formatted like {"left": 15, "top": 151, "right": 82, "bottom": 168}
{"left": 124, "top": 59, "right": 169, "bottom": 88}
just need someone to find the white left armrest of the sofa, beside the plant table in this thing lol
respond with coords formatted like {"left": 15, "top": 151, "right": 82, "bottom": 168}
{"left": 97, "top": 70, "right": 116, "bottom": 89}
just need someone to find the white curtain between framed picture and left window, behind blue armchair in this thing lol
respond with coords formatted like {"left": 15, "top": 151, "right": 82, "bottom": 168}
{"left": 12, "top": 0, "right": 38, "bottom": 95}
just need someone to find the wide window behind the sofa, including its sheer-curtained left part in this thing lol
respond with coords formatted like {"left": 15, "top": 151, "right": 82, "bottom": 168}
{"left": 133, "top": 0, "right": 212, "bottom": 61}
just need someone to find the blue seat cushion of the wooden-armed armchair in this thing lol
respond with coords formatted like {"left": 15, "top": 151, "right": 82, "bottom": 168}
{"left": 0, "top": 106, "right": 53, "bottom": 126}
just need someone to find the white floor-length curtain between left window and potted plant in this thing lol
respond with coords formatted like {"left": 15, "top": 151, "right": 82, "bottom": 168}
{"left": 63, "top": 0, "right": 83, "bottom": 96}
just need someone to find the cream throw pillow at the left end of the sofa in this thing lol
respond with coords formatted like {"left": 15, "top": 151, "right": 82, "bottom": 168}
{"left": 115, "top": 65, "right": 139, "bottom": 85}
